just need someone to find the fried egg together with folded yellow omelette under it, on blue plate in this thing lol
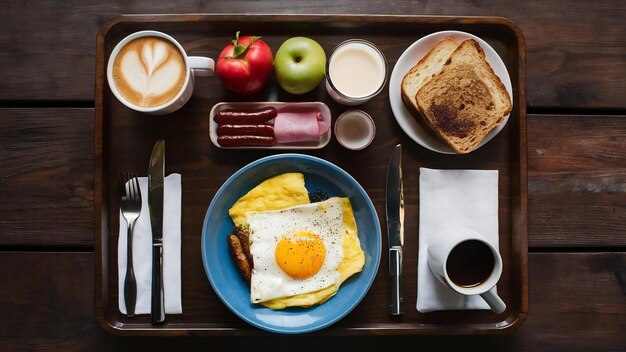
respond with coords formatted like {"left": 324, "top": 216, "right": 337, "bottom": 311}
{"left": 229, "top": 173, "right": 365, "bottom": 309}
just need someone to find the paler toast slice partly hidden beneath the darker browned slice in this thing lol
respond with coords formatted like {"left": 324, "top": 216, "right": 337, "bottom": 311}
{"left": 400, "top": 37, "right": 459, "bottom": 118}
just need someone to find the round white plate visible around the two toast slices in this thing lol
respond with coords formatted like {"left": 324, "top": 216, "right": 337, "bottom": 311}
{"left": 389, "top": 31, "right": 513, "bottom": 154}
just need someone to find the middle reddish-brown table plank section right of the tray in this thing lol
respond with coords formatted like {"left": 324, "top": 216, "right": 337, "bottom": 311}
{"left": 528, "top": 115, "right": 626, "bottom": 248}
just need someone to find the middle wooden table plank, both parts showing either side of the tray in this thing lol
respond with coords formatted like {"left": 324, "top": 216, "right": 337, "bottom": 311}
{"left": 0, "top": 108, "right": 626, "bottom": 249}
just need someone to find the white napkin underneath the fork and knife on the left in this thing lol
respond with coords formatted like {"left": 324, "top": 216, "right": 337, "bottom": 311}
{"left": 117, "top": 174, "right": 183, "bottom": 314}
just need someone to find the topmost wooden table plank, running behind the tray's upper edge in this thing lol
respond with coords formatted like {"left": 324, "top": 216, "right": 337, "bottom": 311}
{"left": 0, "top": 0, "right": 626, "bottom": 109}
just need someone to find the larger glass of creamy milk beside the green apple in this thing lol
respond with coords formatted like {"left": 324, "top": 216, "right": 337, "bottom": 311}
{"left": 326, "top": 39, "right": 387, "bottom": 105}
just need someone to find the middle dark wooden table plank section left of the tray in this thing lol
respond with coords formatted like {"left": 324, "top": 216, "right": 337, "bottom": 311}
{"left": 0, "top": 109, "right": 94, "bottom": 246}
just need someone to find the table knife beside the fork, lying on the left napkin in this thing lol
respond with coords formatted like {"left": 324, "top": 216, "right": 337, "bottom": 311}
{"left": 148, "top": 139, "right": 165, "bottom": 323}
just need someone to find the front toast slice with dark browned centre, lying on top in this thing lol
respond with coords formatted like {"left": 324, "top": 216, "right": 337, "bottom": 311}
{"left": 415, "top": 39, "right": 511, "bottom": 153}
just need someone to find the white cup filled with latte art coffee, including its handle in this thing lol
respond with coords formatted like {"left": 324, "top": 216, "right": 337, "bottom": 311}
{"left": 107, "top": 30, "right": 215, "bottom": 114}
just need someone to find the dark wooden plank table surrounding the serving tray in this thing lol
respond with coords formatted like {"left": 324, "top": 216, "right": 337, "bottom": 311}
{"left": 0, "top": 0, "right": 626, "bottom": 351}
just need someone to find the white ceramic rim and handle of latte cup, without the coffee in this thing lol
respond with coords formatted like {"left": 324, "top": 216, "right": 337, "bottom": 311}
{"left": 107, "top": 30, "right": 215, "bottom": 114}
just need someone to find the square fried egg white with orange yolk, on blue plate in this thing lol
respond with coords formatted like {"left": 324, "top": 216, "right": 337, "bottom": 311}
{"left": 247, "top": 198, "right": 343, "bottom": 303}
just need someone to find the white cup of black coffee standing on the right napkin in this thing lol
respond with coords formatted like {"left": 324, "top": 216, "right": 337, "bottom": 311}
{"left": 428, "top": 228, "right": 506, "bottom": 314}
